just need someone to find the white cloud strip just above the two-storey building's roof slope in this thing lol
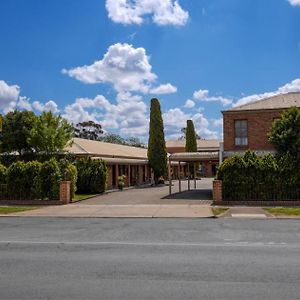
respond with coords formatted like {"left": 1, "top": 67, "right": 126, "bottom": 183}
{"left": 233, "top": 78, "right": 300, "bottom": 107}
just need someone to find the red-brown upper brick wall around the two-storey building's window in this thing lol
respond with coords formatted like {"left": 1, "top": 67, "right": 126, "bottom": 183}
{"left": 223, "top": 110, "right": 282, "bottom": 151}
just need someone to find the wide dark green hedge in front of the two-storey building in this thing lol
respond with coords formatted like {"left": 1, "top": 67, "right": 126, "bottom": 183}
{"left": 217, "top": 151, "right": 300, "bottom": 201}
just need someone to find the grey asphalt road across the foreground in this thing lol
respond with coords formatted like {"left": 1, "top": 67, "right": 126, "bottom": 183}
{"left": 0, "top": 217, "right": 300, "bottom": 299}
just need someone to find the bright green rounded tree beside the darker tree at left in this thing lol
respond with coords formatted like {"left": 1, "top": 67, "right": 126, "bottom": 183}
{"left": 28, "top": 112, "right": 73, "bottom": 156}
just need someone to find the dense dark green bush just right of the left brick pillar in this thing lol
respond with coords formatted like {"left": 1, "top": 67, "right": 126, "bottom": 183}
{"left": 76, "top": 158, "right": 107, "bottom": 194}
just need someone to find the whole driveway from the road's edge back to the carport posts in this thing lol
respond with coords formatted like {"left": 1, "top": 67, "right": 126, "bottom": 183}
{"left": 6, "top": 178, "right": 213, "bottom": 218}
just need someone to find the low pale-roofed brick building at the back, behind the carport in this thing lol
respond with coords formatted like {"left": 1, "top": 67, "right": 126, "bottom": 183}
{"left": 166, "top": 140, "right": 221, "bottom": 178}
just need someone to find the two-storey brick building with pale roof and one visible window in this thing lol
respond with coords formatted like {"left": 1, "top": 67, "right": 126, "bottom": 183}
{"left": 222, "top": 93, "right": 300, "bottom": 157}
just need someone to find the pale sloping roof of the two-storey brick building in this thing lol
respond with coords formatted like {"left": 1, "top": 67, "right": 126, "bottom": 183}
{"left": 225, "top": 92, "right": 300, "bottom": 112}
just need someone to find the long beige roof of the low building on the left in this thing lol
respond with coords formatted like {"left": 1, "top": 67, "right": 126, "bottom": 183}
{"left": 66, "top": 138, "right": 147, "bottom": 159}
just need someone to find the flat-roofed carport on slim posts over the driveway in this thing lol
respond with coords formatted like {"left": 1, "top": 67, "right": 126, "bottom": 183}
{"left": 168, "top": 152, "right": 218, "bottom": 196}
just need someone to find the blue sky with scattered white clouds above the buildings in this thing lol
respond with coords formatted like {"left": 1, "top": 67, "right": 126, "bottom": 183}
{"left": 0, "top": 0, "right": 300, "bottom": 140}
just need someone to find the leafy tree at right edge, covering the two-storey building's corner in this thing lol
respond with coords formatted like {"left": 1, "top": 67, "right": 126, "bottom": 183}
{"left": 269, "top": 107, "right": 300, "bottom": 162}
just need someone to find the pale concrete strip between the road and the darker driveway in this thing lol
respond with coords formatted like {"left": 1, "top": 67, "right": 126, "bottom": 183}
{"left": 5, "top": 204, "right": 213, "bottom": 218}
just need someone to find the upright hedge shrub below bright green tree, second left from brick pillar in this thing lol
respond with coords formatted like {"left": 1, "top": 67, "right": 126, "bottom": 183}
{"left": 40, "top": 158, "right": 62, "bottom": 200}
